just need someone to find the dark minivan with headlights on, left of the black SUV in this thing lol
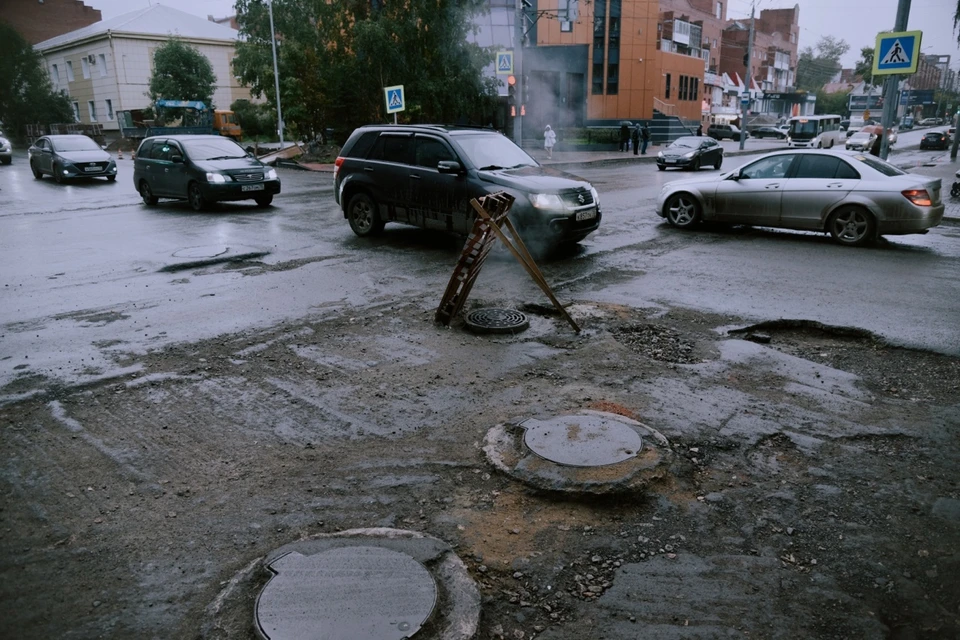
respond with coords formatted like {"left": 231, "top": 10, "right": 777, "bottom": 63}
{"left": 133, "top": 134, "right": 280, "bottom": 211}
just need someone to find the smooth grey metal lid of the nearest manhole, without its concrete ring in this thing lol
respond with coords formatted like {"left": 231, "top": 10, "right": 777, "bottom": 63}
{"left": 257, "top": 546, "right": 437, "bottom": 640}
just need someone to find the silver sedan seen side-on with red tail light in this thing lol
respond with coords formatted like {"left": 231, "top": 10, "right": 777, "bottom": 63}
{"left": 657, "top": 149, "right": 944, "bottom": 245}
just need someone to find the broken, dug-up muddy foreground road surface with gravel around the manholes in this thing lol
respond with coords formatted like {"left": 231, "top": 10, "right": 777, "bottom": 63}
{"left": 0, "top": 299, "right": 960, "bottom": 640}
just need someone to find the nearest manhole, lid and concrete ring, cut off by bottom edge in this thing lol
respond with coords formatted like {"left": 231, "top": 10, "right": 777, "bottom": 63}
{"left": 209, "top": 528, "right": 480, "bottom": 640}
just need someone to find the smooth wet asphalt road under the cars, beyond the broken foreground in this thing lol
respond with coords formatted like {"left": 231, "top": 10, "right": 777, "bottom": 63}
{"left": 0, "top": 141, "right": 960, "bottom": 400}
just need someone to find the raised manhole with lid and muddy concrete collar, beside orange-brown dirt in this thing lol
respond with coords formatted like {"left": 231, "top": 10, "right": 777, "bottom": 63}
{"left": 483, "top": 410, "right": 673, "bottom": 495}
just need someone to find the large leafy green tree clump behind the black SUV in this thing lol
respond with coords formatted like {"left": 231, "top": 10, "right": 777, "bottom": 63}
{"left": 235, "top": 0, "right": 497, "bottom": 137}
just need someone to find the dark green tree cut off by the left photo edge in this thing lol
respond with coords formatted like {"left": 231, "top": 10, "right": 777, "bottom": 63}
{"left": 0, "top": 23, "right": 74, "bottom": 139}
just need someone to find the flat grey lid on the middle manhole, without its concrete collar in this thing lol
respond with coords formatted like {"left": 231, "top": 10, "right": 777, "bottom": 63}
{"left": 523, "top": 415, "right": 643, "bottom": 467}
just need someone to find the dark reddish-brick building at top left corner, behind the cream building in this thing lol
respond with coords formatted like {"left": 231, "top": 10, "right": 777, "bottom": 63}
{"left": 0, "top": 0, "right": 100, "bottom": 44}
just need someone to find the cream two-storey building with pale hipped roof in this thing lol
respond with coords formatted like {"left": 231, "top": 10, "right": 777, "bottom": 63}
{"left": 34, "top": 5, "right": 250, "bottom": 130}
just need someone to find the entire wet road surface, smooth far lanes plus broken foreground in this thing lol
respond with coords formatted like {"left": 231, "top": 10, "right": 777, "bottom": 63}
{"left": 0, "top": 162, "right": 960, "bottom": 640}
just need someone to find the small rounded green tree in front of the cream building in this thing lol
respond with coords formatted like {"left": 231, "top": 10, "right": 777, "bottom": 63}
{"left": 147, "top": 38, "right": 217, "bottom": 109}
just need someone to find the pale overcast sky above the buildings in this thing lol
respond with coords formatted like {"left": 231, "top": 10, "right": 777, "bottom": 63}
{"left": 92, "top": 0, "right": 960, "bottom": 69}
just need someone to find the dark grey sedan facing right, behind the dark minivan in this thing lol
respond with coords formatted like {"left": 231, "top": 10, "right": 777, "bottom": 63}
{"left": 27, "top": 135, "right": 117, "bottom": 183}
